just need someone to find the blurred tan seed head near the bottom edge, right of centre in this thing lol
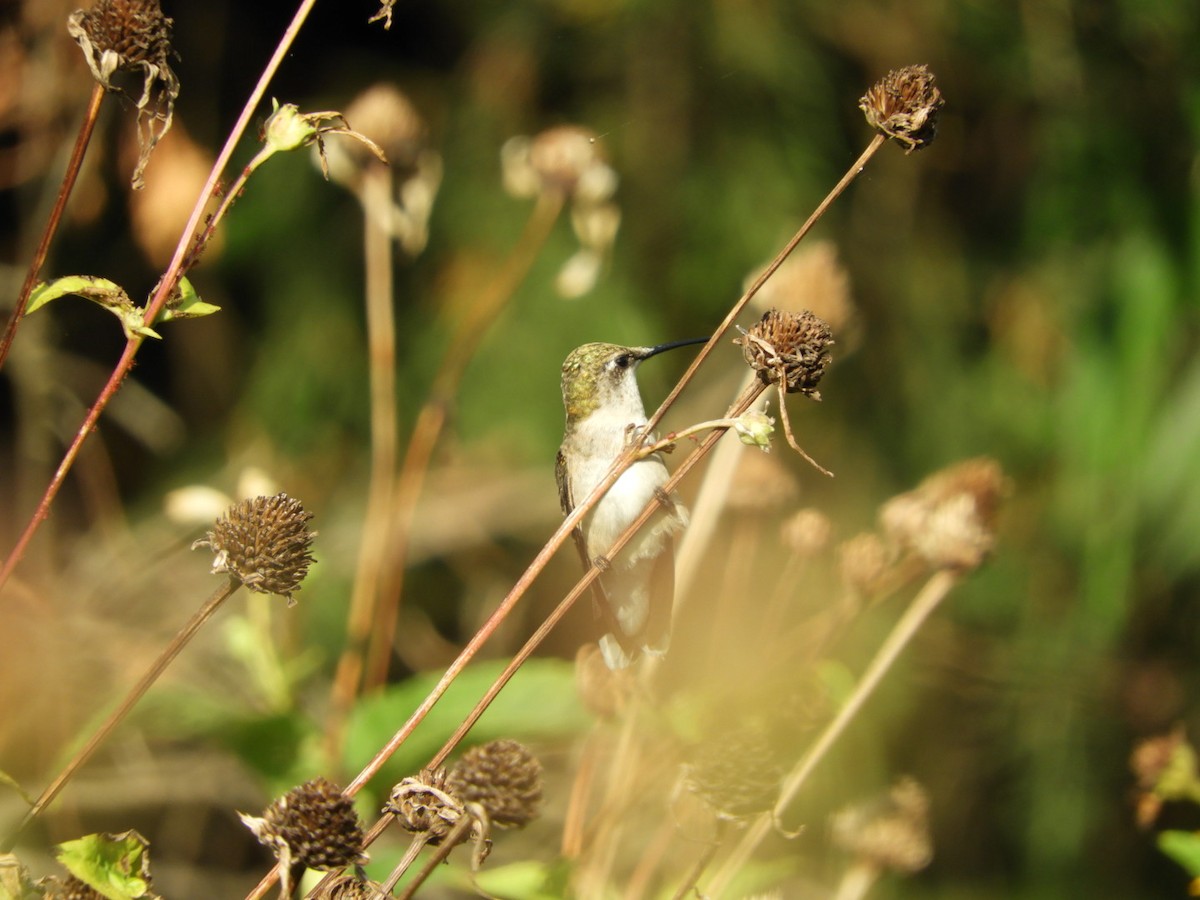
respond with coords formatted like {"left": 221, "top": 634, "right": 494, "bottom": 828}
{"left": 833, "top": 778, "right": 934, "bottom": 872}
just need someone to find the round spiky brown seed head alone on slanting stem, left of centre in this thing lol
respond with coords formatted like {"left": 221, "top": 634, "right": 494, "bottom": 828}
{"left": 192, "top": 493, "right": 317, "bottom": 606}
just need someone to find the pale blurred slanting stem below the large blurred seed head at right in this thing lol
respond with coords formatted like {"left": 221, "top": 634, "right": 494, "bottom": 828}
{"left": 707, "top": 570, "right": 960, "bottom": 898}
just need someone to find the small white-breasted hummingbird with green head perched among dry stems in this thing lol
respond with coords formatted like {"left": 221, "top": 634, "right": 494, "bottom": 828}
{"left": 554, "top": 337, "right": 708, "bottom": 670}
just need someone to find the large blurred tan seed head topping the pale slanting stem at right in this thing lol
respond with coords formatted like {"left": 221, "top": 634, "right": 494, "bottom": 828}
{"left": 880, "top": 457, "right": 1008, "bottom": 570}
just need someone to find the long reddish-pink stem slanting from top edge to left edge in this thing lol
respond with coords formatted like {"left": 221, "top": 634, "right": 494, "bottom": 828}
{"left": 0, "top": 0, "right": 317, "bottom": 600}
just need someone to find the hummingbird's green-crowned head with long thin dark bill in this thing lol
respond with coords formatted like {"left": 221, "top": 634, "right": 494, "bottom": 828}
{"left": 563, "top": 337, "right": 708, "bottom": 421}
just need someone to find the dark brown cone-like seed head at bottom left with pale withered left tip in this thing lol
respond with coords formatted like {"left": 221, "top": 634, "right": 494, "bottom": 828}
{"left": 239, "top": 778, "right": 366, "bottom": 870}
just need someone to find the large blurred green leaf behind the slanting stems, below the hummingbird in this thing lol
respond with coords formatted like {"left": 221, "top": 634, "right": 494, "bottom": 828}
{"left": 346, "top": 659, "right": 592, "bottom": 784}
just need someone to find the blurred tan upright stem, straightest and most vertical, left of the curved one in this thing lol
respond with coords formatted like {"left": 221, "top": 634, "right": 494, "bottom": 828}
{"left": 325, "top": 166, "right": 396, "bottom": 763}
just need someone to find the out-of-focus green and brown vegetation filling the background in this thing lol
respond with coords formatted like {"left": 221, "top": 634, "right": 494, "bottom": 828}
{"left": 0, "top": 0, "right": 1200, "bottom": 898}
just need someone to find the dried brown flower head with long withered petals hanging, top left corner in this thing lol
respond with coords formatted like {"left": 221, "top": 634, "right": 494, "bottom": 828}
{"left": 67, "top": 0, "right": 179, "bottom": 191}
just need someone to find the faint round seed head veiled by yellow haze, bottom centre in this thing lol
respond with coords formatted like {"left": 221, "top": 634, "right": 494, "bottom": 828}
{"left": 684, "top": 724, "right": 785, "bottom": 820}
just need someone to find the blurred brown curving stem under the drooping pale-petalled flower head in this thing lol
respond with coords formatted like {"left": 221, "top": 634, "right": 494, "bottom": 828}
{"left": 364, "top": 191, "right": 565, "bottom": 690}
